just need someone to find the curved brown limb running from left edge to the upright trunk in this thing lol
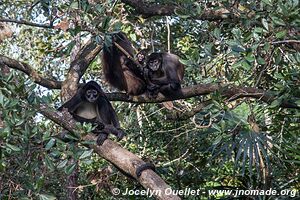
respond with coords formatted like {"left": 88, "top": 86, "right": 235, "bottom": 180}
{"left": 0, "top": 55, "right": 62, "bottom": 89}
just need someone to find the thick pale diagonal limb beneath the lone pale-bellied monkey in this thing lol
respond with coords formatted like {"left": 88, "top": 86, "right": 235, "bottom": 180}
{"left": 38, "top": 105, "right": 180, "bottom": 200}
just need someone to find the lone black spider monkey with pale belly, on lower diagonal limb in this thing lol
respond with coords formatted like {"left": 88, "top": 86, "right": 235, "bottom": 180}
{"left": 59, "top": 81, "right": 125, "bottom": 145}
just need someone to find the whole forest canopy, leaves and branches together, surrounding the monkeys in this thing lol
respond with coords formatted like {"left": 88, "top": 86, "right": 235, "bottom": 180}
{"left": 0, "top": 0, "right": 300, "bottom": 200}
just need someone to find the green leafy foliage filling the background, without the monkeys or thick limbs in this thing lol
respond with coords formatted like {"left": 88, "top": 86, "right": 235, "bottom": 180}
{"left": 0, "top": 0, "right": 300, "bottom": 200}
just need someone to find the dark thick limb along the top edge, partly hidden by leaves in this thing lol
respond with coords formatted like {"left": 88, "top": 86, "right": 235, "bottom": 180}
{"left": 121, "top": 0, "right": 233, "bottom": 21}
